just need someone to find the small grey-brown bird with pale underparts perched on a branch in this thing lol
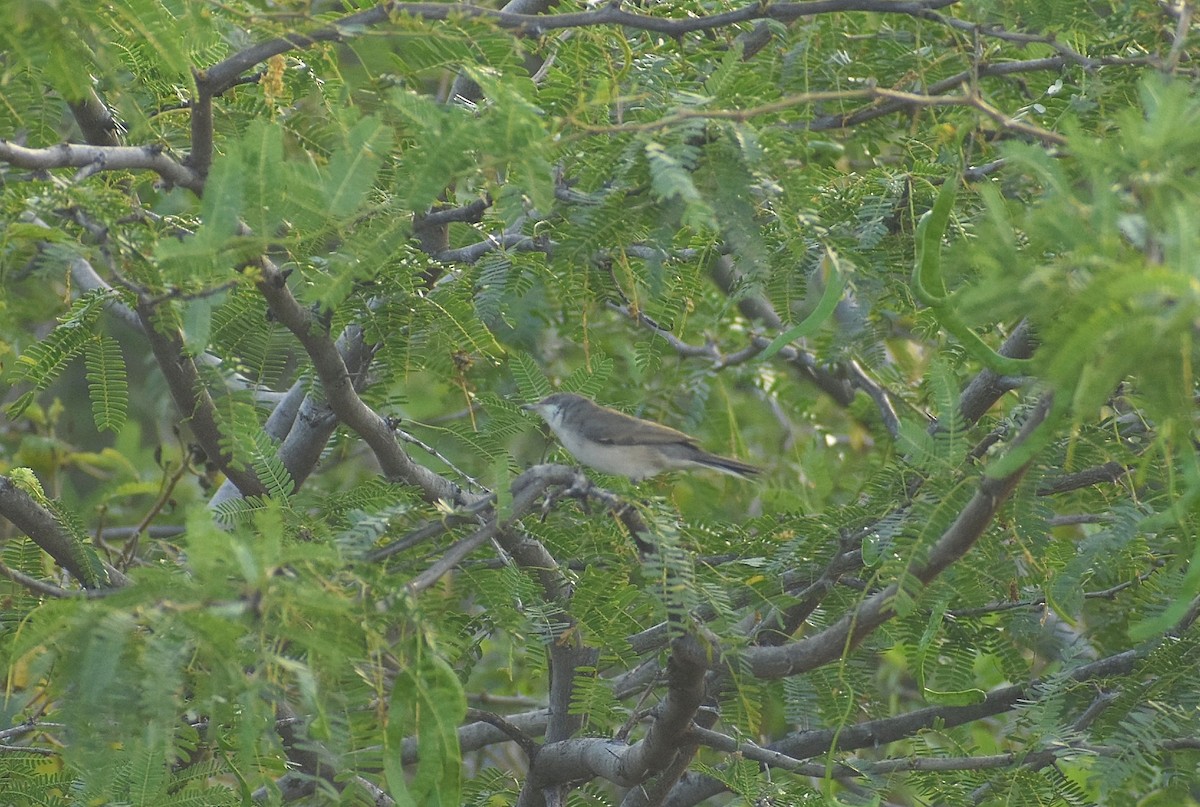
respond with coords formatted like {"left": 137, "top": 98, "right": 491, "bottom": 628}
{"left": 521, "top": 393, "right": 758, "bottom": 482}
